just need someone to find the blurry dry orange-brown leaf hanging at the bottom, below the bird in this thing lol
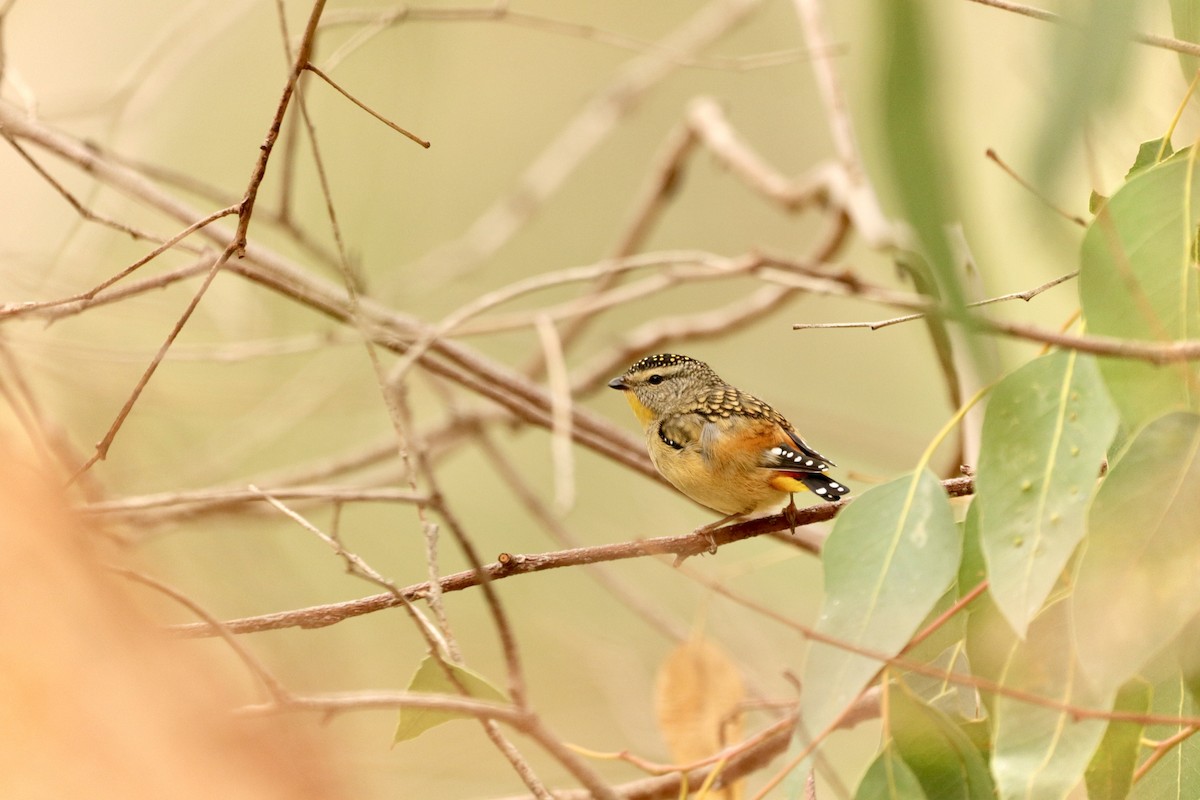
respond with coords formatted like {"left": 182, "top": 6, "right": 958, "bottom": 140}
{"left": 654, "top": 637, "right": 745, "bottom": 800}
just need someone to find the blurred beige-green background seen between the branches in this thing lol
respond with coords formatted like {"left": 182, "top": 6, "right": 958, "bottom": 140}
{"left": 0, "top": 0, "right": 1194, "bottom": 798}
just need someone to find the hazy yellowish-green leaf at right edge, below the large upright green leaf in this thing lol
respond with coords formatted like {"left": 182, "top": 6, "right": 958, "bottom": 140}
{"left": 1070, "top": 411, "right": 1200, "bottom": 691}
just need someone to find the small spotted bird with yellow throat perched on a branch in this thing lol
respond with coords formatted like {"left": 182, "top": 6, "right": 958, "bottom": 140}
{"left": 608, "top": 353, "right": 850, "bottom": 534}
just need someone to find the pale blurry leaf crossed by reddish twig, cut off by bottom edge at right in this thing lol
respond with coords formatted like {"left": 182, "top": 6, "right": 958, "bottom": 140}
{"left": 991, "top": 601, "right": 1115, "bottom": 800}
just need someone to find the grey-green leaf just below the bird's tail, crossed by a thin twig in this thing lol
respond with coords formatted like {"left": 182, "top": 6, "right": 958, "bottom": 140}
{"left": 800, "top": 470, "right": 961, "bottom": 735}
